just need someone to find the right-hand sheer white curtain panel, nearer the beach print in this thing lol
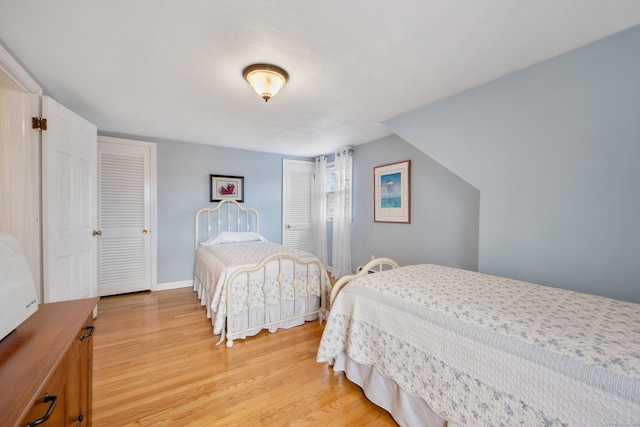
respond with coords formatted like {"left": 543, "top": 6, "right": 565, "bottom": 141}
{"left": 331, "top": 148, "right": 353, "bottom": 278}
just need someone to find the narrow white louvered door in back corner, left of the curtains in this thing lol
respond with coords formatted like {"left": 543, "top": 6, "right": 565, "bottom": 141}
{"left": 282, "top": 159, "right": 314, "bottom": 253}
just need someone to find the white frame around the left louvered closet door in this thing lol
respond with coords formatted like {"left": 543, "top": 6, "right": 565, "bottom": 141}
{"left": 98, "top": 135, "right": 158, "bottom": 291}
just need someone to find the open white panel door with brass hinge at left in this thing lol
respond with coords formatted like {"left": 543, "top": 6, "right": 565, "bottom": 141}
{"left": 42, "top": 96, "right": 98, "bottom": 302}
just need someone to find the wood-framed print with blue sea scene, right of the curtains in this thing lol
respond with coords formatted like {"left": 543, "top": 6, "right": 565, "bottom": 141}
{"left": 373, "top": 160, "right": 411, "bottom": 224}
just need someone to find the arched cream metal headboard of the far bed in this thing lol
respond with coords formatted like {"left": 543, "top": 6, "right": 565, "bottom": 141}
{"left": 194, "top": 200, "right": 260, "bottom": 249}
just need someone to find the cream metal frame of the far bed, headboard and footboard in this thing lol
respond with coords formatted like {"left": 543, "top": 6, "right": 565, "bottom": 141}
{"left": 194, "top": 200, "right": 327, "bottom": 347}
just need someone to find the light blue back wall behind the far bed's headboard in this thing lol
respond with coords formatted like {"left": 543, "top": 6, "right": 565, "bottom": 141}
{"left": 157, "top": 141, "right": 309, "bottom": 284}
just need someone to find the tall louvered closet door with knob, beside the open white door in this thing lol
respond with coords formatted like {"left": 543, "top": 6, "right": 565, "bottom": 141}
{"left": 98, "top": 141, "right": 154, "bottom": 296}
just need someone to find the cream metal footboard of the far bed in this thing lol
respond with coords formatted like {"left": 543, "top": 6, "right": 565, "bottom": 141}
{"left": 220, "top": 252, "right": 329, "bottom": 347}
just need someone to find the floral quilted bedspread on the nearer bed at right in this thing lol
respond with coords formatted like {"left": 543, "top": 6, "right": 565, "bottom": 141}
{"left": 317, "top": 265, "right": 640, "bottom": 426}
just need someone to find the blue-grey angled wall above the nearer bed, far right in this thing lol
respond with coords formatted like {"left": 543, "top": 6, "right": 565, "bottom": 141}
{"left": 386, "top": 27, "right": 640, "bottom": 302}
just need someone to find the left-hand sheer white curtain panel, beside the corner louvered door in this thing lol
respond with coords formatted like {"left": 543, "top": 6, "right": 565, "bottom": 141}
{"left": 311, "top": 156, "right": 329, "bottom": 266}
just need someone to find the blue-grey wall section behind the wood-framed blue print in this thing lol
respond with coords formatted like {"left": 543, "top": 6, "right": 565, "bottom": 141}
{"left": 351, "top": 135, "right": 480, "bottom": 270}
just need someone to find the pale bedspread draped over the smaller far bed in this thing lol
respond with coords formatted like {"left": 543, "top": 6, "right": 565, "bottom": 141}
{"left": 194, "top": 241, "right": 329, "bottom": 334}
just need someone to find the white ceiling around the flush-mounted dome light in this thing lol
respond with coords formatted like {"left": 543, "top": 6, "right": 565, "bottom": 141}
{"left": 0, "top": 0, "right": 640, "bottom": 156}
